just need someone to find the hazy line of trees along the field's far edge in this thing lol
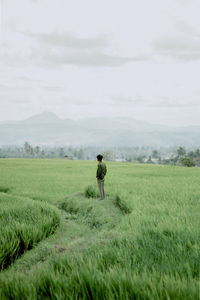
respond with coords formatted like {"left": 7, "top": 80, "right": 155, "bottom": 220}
{"left": 0, "top": 141, "right": 200, "bottom": 167}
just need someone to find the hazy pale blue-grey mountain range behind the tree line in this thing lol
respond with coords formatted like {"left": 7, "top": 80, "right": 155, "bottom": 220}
{"left": 0, "top": 112, "right": 200, "bottom": 148}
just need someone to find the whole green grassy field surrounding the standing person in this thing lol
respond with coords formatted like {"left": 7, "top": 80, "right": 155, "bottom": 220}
{"left": 0, "top": 159, "right": 200, "bottom": 300}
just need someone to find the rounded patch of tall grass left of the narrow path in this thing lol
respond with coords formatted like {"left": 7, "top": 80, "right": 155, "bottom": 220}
{"left": 0, "top": 194, "right": 60, "bottom": 270}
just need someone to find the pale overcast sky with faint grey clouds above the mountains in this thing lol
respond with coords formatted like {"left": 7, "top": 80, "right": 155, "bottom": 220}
{"left": 0, "top": 0, "right": 200, "bottom": 125}
